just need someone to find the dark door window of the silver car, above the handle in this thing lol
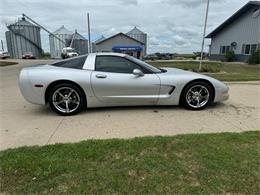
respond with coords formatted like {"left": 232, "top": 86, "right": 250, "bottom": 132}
{"left": 95, "top": 56, "right": 140, "bottom": 74}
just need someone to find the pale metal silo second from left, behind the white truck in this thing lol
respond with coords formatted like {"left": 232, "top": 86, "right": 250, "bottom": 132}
{"left": 49, "top": 25, "right": 72, "bottom": 58}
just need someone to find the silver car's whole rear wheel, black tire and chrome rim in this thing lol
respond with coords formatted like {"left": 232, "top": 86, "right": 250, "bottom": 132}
{"left": 48, "top": 83, "right": 86, "bottom": 116}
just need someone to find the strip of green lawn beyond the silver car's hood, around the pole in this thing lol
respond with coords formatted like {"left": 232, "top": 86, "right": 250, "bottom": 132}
{"left": 148, "top": 61, "right": 260, "bottom": 81}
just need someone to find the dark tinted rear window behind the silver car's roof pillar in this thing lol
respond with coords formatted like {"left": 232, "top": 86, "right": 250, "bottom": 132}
{"left": 52, "top": 55, "right": 87, "bottom": 69}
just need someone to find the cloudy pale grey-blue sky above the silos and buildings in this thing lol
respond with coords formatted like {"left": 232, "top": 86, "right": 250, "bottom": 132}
{"left": 0, "top": 0, "right": 252, "bottom": 53}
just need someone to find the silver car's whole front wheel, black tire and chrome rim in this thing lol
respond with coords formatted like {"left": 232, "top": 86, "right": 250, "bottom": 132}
{"left": 181, "top": 81, "right": 213, "bottom": 110}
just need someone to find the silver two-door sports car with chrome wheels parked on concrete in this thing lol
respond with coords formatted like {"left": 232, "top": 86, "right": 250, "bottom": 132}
{"left": 19, "top": 53, "right": 228, "bottom": 115}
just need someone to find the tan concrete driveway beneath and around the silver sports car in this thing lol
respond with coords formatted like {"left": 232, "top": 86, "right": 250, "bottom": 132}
{"left": 0, "top": 60, "right": 260, "bottom": 150}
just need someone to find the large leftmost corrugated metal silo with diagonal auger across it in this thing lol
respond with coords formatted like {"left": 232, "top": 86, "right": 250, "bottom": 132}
{"left": 5, "top": 17, "right": 43, "bottom": 58}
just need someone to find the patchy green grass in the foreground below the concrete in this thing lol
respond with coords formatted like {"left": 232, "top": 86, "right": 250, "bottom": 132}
{"left": 0, "top": 132, "right": 260, "bottom": 194}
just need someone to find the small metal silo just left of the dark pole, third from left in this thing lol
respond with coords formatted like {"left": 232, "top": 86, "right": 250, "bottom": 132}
{"left": 66, "top": 31, "right": 88, "bottom": 55}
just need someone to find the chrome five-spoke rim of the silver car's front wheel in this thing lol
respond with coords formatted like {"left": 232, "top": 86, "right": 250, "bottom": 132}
{"left": 186, "top": 85, "right": 210, "bottom": 109}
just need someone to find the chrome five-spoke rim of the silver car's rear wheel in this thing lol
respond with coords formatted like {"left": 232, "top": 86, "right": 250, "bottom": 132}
{"left": 52, "top": 87, "right": 80, "bottom": 114}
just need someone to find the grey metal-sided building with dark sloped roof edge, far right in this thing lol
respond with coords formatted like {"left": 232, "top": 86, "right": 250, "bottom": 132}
{"left": 206, "top": 1, "right": 260, "bottom": 61}
